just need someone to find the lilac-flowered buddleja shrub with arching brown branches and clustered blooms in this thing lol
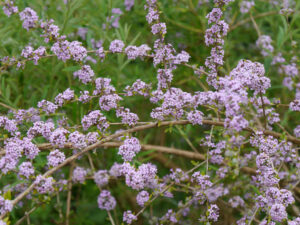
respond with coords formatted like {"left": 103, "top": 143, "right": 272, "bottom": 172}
{"left": 0, "top": 0, "right": 300, "bottom": 225}
